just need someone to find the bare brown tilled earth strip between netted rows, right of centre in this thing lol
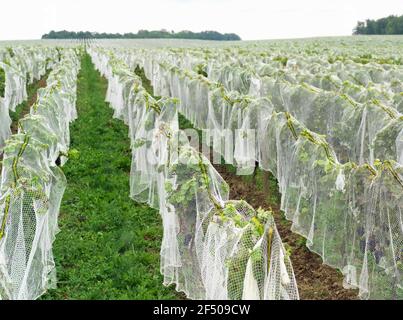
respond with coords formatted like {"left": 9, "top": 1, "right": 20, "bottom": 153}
{"left": 215, "top": 165, "right": 358, "bottom": 300}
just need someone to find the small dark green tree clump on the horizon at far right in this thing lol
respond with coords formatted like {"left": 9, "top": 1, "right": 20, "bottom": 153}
{"left": 353, "top": 15, "right": 403, "bottom": 34}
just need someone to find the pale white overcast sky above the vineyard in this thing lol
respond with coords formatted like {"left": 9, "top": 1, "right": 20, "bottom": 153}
{"left": 0, "top": 0, "right": 403, "bottom": 40}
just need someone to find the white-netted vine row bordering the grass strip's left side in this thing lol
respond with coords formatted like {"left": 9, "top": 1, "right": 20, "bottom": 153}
{"left": 0, "top": 49, "right": 80, "bottom": 299}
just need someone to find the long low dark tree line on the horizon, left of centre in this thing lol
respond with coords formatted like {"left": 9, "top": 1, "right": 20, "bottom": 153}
{"left": 42, "top": 30, "right": 241, "bottom": 41}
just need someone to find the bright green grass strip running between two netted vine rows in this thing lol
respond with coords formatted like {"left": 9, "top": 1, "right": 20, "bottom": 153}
{"left": 43, "top": 55, "right": 178, "bottom": 299}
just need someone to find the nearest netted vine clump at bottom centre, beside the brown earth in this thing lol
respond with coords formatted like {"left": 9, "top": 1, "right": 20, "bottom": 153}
{"left": 202, "top": 201, "right": 298, "bottom": 300}
